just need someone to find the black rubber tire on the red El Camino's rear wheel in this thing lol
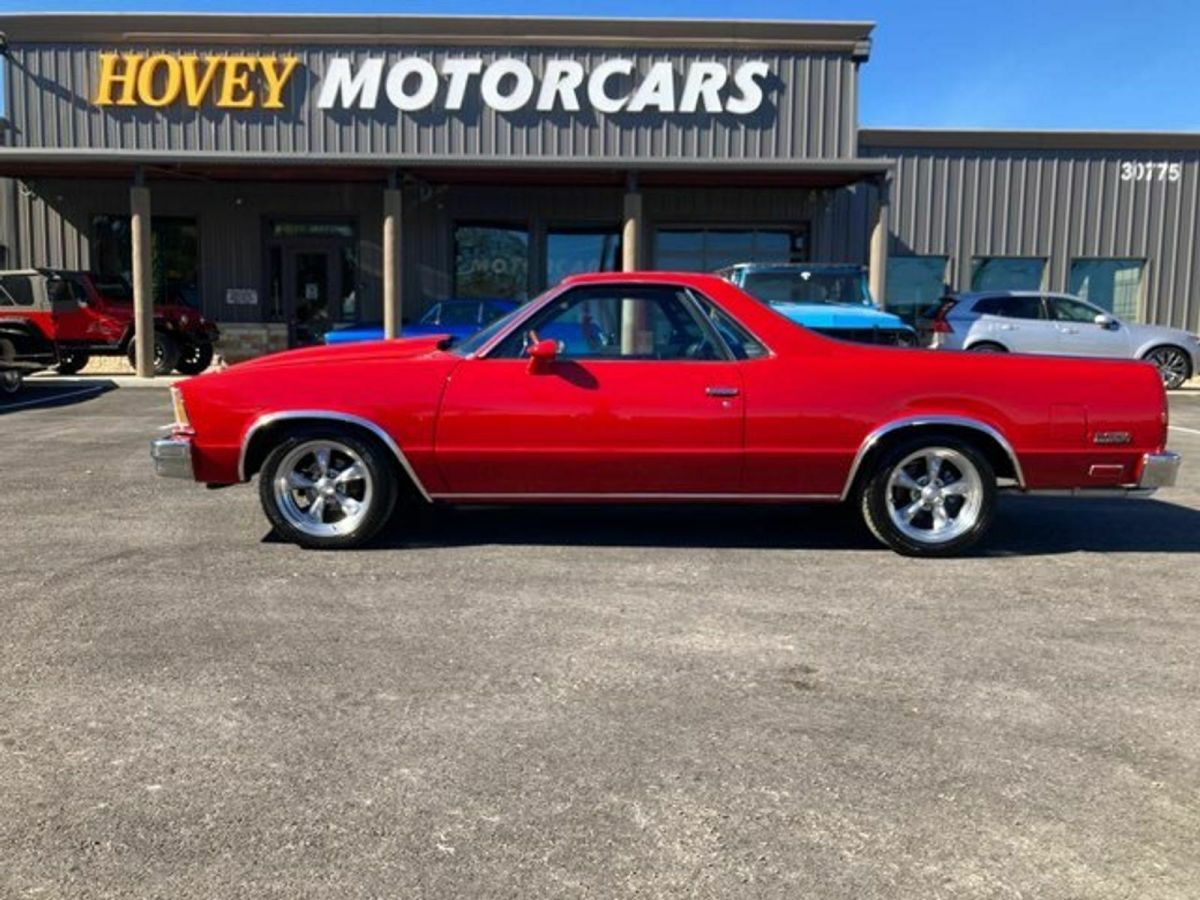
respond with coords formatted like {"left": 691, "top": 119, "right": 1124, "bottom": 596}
{"left": 858, "top": 433, "right": 996, "bottom": 557}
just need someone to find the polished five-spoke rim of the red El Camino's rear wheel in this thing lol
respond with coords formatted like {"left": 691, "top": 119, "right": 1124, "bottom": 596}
{"left": 887, "top": 446, "right": 984, "bottom": 544}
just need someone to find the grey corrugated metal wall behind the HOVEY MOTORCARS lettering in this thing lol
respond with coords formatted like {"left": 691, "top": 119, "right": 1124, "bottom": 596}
{"left": 8, "top": 44, "right": 858, "bottom": 161}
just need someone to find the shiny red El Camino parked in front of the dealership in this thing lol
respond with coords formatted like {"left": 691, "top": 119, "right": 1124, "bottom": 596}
{"left": 152, "top": 272, "right": 1180, "bottom": 556}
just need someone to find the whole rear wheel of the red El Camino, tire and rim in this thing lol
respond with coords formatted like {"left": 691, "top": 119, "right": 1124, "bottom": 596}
{"left": 860, "top": 436, "right": 996, "bottom": 557}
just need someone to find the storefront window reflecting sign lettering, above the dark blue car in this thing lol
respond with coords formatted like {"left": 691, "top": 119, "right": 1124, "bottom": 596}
{"left": 454, "top": 224, "right": 529, "bottom": 300}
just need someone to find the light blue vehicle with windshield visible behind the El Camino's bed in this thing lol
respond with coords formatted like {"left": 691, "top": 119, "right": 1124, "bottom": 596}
{"left": 716, "top": 263, "right": 917, "bottom": 347}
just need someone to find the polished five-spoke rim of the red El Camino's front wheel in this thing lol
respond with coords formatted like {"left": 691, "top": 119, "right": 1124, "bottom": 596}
{"left": 275, "top": 440, "right": 374, "bottom": 538}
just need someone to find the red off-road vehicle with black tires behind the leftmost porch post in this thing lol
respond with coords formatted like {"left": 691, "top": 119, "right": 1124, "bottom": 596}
{"left": 0, "top": 269, "right": 220, "bottom": 374}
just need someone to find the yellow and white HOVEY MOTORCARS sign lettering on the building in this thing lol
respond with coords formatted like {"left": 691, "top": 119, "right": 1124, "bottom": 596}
{"left": 95, "top": 53, "right": 770, "bottom": 115}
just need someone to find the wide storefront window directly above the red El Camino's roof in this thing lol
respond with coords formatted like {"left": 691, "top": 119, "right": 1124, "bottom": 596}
{"left": 654, "top": 226, "right": 809, "bottom": 272}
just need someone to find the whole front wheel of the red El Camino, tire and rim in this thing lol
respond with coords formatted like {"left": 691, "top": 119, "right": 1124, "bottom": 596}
{"left": 258, "top": 430, "right": 397, "bottom": 550}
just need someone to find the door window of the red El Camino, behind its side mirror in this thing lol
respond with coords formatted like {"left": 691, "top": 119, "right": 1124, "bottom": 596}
{"left": 490, "top": 284, "right": 725, "bottom": 360}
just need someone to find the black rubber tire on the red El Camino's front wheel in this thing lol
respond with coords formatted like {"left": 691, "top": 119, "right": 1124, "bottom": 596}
{"left": 258, "top": 426, "right": 400, "bottom": 550}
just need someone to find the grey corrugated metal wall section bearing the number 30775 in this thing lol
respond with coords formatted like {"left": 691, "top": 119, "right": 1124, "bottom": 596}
{"left": 859, "top": 138, "right": 1200, "bottom": 331}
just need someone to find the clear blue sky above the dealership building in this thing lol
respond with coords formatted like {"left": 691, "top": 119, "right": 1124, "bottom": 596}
{"left": 0, "top": 0, "right": 1200, "bottom": 131}
